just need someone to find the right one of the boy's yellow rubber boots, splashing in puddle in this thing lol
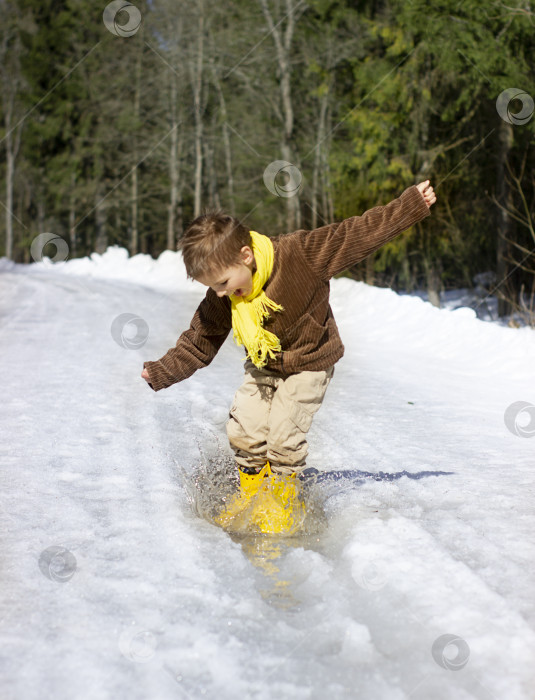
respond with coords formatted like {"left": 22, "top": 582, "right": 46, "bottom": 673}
{"left": 251, "top": 472, "right": 306, "bottom": 535}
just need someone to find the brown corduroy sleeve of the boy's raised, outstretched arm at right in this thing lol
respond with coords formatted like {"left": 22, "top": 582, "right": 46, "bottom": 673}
{"left": 301, "top": 185, "right": 429, "bottom": 280}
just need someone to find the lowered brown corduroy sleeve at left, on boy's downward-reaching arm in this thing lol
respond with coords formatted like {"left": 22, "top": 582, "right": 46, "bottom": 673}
{"left": 143, "top": 289, "right": 232, "bottom": 391}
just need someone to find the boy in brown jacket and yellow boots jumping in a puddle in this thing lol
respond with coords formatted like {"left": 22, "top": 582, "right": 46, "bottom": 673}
{"left": 141, "top": 180, "right": 436, "bottom": 533}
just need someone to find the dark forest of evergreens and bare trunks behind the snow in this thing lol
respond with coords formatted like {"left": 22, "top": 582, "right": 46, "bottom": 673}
{"left": 0, "top": 0, "right": 535, "bottom": 319}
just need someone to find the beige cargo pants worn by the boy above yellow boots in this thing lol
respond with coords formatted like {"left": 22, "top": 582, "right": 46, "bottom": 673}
{"left": 226, "top": 360, "right": 334, "bottom": 474}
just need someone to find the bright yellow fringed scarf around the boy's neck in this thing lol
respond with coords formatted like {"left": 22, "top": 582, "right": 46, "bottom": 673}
{"left": 230, "top": 231, "right": 283, "bottom": 367}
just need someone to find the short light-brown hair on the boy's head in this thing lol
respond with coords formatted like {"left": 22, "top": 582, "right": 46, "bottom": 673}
{"left": 180, "top": 211, "right": 252, "bottom": 279}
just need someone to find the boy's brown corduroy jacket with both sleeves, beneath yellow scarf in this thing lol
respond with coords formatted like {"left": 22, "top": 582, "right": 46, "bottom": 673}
{"left": 144, "top": 185, "right": 429, "bottom": 391}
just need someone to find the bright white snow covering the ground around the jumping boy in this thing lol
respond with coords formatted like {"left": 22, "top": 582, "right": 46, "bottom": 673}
{"left": 0, "top": 247, "right": 535, "bottom": 700}
